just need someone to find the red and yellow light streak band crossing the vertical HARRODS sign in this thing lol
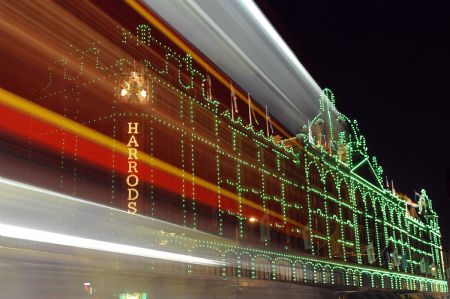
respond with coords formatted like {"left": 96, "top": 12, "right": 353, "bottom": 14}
{"left": 0, "top": 88, "right": 316, "bottom": 239}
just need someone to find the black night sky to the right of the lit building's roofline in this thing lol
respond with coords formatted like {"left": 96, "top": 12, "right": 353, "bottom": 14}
{"left": 257, "top": 0, "right": 450, "bottom": 249}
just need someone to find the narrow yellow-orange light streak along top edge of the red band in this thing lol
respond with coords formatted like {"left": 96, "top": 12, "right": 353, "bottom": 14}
{"left": 0, "top": 88, "right": 312, "bottom": 233}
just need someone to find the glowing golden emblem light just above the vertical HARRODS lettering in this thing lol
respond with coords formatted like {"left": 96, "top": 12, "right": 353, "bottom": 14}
{"left": 119, "top": 64, "right": 149, "bottom": 104}
